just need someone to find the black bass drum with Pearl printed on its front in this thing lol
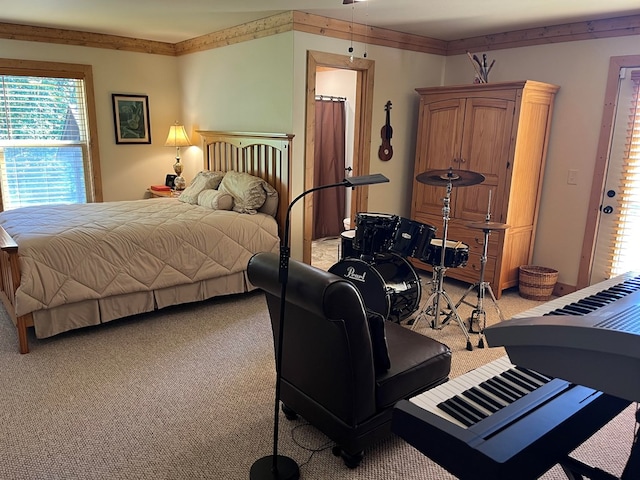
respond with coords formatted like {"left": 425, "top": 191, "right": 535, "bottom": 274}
{"left": 329, "top": 253, "right": 422, "bottom": 322}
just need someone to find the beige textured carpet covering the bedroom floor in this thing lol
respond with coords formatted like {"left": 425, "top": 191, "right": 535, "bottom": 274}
{"left": 0, "top": 248, "right": 635, "bottom": 480}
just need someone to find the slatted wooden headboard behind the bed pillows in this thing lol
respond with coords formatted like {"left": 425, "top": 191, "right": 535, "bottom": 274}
{"left": 197, "top": 130, "right": 293, "bottom": 238}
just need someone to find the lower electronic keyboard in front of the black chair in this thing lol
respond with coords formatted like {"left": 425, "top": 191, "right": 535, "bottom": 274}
{"left": 391, "top": 356, "right": 629, "bottom": 480}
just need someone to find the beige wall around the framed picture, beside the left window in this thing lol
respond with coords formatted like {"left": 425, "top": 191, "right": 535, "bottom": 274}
{"left": 0, "top": 40, "right": 180, "bottom": 201}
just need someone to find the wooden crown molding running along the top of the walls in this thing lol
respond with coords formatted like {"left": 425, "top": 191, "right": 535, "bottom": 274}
{"left": 0, "top": 10, "right": 640, "bottom": 56}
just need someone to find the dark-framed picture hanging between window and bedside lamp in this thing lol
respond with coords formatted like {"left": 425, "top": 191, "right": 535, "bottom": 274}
{"left": 111, "top": 93, "right": 151, "bottom": 144}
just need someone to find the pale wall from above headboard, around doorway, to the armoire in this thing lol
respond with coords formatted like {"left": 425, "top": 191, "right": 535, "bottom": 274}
{"left": 179, "top": 32, "right": 444, "bottom": 258}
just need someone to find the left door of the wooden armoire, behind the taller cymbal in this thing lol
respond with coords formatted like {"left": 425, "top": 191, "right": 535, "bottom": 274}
{"left": 413, "top": 98, "right": 465, "bottom": 215}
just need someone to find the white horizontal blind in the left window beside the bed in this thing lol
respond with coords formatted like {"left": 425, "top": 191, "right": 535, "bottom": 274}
{"left": 0, "top": 75, "right": 88, "bottom": 210}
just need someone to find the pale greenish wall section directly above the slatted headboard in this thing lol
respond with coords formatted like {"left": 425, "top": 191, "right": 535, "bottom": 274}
{"left": 178, "top": 33, "right": 299, "bottom": 192}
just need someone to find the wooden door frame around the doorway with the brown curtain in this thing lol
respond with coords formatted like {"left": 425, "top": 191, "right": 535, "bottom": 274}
{"left": 302, "top": 51, "right": 374, "bottom": 264}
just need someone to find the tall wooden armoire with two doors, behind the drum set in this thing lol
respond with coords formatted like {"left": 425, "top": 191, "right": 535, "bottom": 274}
{"left": 411, "top": 80, "right": 559, "bottom": 298}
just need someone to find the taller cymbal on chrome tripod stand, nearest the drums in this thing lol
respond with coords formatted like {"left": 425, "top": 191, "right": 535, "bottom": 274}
{"left": 411, "top": 168, "right": 484, "bottom": 351}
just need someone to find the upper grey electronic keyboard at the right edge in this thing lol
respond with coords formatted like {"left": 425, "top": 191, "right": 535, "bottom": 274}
{"left": 485, "top": 274, "right": 640, "bottom": 401}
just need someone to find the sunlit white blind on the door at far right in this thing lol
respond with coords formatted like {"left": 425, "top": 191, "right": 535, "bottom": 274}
{"left": 610, "top": 70, "right": 640, "bottom": 276}
